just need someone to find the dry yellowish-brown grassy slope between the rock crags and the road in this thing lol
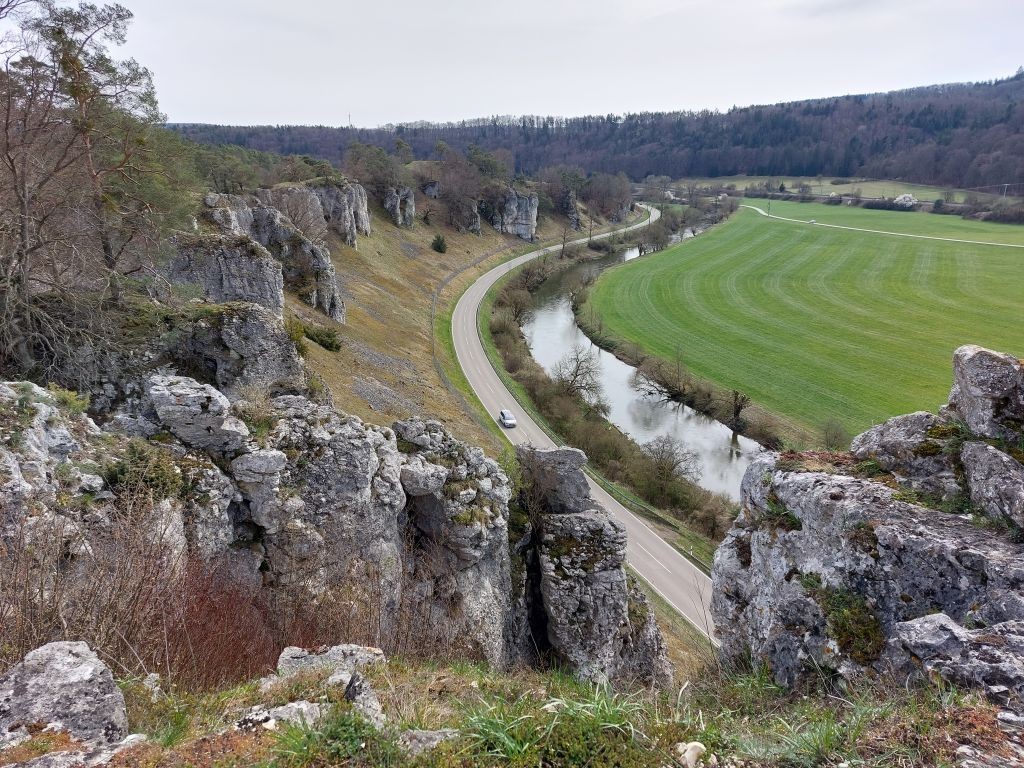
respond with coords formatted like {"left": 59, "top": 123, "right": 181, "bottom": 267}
{"left": 288, "top": 200, "right": 577, "bottom": 452}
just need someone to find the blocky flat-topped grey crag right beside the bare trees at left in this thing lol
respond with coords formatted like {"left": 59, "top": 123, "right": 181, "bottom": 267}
{"left": 167, "top": 234, "right": 285, "bottom": 317}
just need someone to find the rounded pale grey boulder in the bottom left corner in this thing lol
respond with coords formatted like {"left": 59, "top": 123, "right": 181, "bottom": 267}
{"left": 0, "top": 642, "right": 128, "bottom": 748}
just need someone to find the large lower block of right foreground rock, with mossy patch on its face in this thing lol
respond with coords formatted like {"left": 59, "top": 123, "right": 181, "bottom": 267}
{"left": 712, "top": 454, "right": 1024, "bottom": 685}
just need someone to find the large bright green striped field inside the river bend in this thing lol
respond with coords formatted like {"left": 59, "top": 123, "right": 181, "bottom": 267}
{"left": 590, "top": 201, "right": 1024, "bottom": 431}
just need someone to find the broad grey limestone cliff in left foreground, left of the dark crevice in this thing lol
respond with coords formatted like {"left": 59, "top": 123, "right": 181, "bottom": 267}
{"left": 0, "top": 376, "right": 519, "bottom": 665}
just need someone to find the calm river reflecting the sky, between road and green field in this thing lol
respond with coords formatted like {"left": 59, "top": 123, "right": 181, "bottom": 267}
{"left": 522, "top": 243, "right": 761, "bottom": 501}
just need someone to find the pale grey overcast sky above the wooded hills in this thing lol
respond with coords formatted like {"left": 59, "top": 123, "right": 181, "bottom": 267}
{"left": 114, "top": 0, "right": 1024, "bottom": 127}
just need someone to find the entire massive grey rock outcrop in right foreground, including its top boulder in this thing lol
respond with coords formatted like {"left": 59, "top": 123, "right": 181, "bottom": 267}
{"left": 712, "top": 346, "right": 1024, "bottom": 711}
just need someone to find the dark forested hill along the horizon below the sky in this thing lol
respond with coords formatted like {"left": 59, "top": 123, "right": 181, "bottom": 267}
{"left": 173, "top": 70, "right": 1024, "bottom": 187}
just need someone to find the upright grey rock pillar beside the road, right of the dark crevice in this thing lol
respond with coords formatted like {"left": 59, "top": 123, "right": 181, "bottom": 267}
{"left": 516, "top": 446, "right": 671, "bottom": 684}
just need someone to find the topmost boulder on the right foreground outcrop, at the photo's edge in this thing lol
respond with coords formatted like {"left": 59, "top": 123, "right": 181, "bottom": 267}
{"left": 948, "top": 344, "right": 1024, "bottom": 438}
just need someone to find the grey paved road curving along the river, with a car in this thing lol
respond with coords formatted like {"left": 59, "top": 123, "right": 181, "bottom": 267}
{"left": 452, "top": 206, "right": 715, "bottom": 642}
